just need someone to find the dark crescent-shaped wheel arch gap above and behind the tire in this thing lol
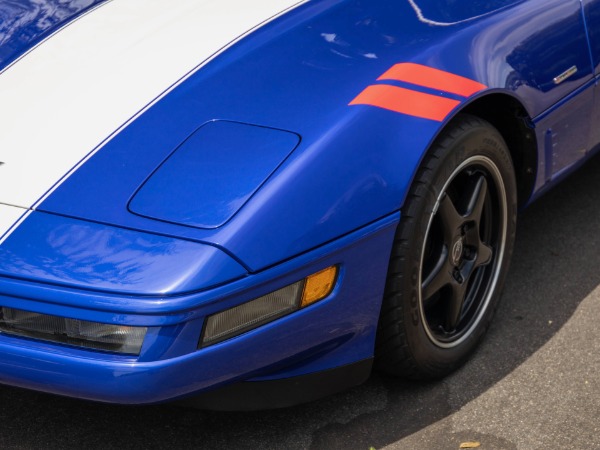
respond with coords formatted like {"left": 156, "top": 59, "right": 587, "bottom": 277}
{"left": 460, "top": 93, "right": 538, "bottom": 207}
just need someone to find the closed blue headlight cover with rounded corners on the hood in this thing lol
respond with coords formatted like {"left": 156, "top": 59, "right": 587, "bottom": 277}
{"left": 129, "top": 120, "right": 300, "bottom": 228}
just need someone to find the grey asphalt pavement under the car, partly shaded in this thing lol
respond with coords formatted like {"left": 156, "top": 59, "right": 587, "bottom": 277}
{"left": 0, "top": 153, "right": 600, "bottom": 450}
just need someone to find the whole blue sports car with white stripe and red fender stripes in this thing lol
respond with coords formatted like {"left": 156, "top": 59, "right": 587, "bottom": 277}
{"left": 0, "top": 0, "right": 600, "bottom": 409}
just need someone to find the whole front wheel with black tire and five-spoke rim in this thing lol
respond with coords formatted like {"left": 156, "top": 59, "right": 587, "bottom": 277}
{"left": 375, "top": 115, "right": 517, "bottom": 379}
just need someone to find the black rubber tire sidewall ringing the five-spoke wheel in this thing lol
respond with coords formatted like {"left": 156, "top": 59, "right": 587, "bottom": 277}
{"left": 402, "top": 120, "right": 517, "bottom": 377}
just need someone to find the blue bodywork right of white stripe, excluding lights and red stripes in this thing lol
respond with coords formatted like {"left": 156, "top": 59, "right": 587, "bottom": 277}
{"left": 0, "top": 0, "right": 600, "bottom": 403}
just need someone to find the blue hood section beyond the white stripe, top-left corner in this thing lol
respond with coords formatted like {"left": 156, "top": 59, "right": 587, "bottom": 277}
{"left": 0, "top": 0, "right": 106, "bottom": 71}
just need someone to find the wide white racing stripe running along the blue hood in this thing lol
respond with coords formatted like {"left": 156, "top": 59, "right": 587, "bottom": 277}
{"left": 0, "top": 0, "right": 305, "bottom": 236}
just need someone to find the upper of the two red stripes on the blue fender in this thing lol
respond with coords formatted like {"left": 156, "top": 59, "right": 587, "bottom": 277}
{"left": 379, "top": 63, "right": 487, "bottom": 97}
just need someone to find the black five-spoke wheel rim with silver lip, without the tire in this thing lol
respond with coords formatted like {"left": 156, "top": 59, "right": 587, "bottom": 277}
{"left": 420, "top": 156, "right": 507, "bottom": 347}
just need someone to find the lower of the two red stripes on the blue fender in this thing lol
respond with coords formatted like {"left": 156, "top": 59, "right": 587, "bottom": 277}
{"left": 350, "top": 84, "right": 460, "bottom": 122}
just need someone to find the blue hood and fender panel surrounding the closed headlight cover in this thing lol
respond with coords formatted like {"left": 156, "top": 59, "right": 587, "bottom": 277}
{"left": 40, "top": 0, "right": 592, "bottom": 271}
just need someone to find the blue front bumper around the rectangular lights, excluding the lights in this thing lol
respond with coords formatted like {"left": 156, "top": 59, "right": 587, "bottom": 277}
{"left": 0, "top": 214, "right": 399, "bottom": 404}
